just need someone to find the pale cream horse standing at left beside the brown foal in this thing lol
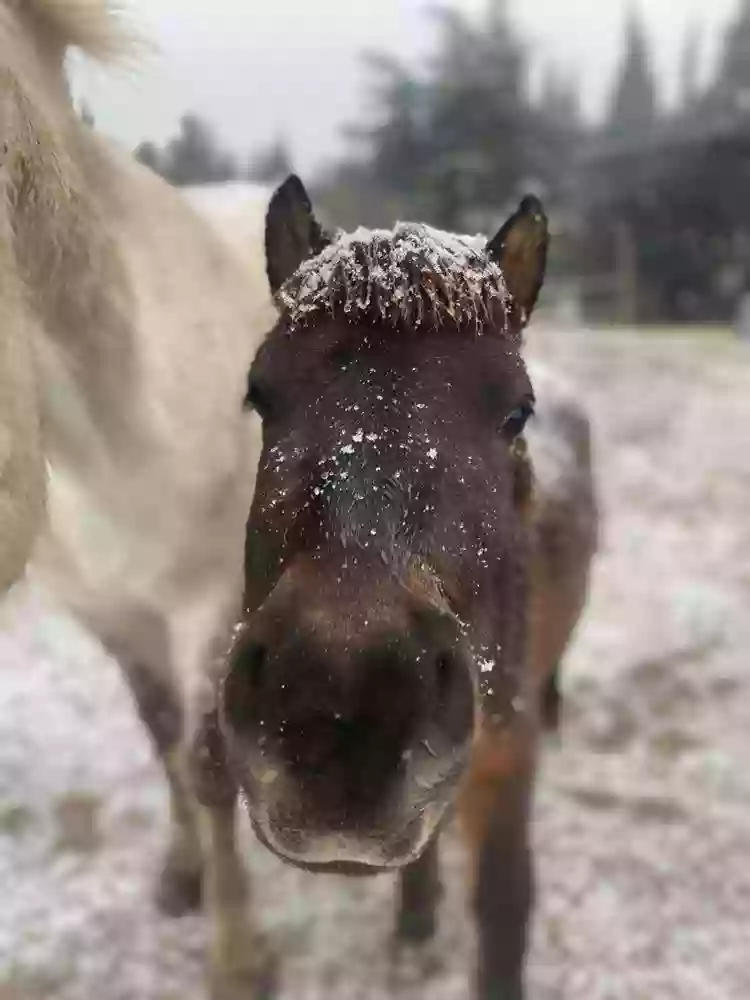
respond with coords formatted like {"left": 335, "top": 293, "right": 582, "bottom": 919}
{"left": 0, "top": 0, "right": 280, "bottom": 1000}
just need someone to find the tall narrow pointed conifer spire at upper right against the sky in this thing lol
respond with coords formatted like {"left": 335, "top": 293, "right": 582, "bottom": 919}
{"left": 608, "top": 10, "right": 658, "bottom": 141}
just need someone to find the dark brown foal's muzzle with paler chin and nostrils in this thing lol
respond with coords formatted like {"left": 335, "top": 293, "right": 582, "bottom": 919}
{"left": 221, "top": 568, "right": 475, "bottom": 871}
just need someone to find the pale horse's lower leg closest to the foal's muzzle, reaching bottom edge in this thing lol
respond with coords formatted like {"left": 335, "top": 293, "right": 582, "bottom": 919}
{"left": 194, "top": 715, "right": 278, "bottom": 1000}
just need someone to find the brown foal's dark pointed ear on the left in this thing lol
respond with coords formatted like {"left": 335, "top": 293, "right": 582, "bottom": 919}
{"left": 266, "top": 174, "right": 331, "bottom": 295}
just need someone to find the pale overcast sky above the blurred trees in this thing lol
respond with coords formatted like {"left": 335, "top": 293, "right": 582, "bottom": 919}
{"left": 73, "top": 0, "right": 739, "bottom": 172}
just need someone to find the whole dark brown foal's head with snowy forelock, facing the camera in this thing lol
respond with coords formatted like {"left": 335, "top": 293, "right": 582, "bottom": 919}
{"left": 221, "top": 178, "right": 547, "bottom": 871}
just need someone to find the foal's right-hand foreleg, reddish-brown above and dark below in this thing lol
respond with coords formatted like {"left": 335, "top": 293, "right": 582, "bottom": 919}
{"left": 460, "top": 731, "right": 534, "bottom": 1000}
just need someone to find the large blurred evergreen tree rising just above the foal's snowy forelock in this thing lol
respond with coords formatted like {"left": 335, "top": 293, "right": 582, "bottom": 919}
{"left": 349, "top": 0, "right": 534, "bottom": 229}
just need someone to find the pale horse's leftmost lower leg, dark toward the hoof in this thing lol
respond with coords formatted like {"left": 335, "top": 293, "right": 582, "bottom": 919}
{"left": 124, "top": 665, "right": 203, "bottom": 916}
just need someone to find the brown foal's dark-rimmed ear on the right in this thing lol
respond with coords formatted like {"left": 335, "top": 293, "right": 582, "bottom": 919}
{"left": 486, "top": 195, "right": 549, "bottom": 326}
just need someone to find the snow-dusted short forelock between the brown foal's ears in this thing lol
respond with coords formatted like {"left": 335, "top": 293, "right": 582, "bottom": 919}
{"left": 277, "top": 222, "right": 508, "bottom": 334}
